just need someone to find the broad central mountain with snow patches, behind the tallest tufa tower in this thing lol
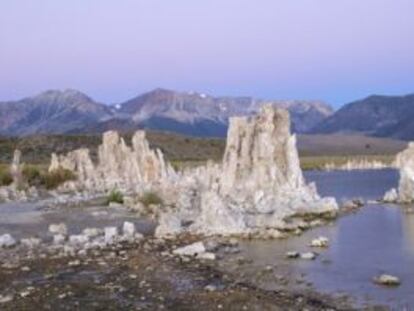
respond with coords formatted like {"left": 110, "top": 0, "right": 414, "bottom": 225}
{"left": 111, "top": 89, "right": 333, "bottom": 136}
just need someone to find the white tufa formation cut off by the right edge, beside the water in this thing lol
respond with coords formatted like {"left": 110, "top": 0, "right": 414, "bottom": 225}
{"left": 383, "top": 142, "right": 414, "bottom": 203}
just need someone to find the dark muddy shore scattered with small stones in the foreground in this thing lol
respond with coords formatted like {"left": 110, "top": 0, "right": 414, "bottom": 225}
{"left": 0, "top": 233, "right": 388, "bottom": 310}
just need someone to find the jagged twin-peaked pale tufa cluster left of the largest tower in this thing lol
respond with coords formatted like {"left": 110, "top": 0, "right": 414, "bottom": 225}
{"left": 49, "top": 131, "right": 175, "bottom": 192}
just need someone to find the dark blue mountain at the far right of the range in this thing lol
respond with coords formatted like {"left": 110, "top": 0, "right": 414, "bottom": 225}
{"left": 311, "top": 94, "right": 414, "bottom": 140}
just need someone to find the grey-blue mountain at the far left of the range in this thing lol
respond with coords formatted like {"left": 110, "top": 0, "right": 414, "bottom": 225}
{"left": 0, "top": 90, "right": 113, "bottom": 136}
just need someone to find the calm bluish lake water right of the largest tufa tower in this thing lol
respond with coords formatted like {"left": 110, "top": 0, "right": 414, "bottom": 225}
{"left": 226, "top": 170, "right": 414, "bottom": 310}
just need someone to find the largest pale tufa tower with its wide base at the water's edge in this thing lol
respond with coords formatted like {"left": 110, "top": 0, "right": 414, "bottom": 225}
{"left": 156, "top": 106, "right": 337, "bottom": 236}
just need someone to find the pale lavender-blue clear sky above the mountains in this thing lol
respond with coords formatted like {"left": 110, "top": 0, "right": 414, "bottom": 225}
{"left": 0, "top": 0, "right": 414, "bottom": 107}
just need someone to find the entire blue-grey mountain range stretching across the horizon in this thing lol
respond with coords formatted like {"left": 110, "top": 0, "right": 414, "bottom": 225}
{"left": 0, "top": 88, "right": 414, "bottom": 140}
